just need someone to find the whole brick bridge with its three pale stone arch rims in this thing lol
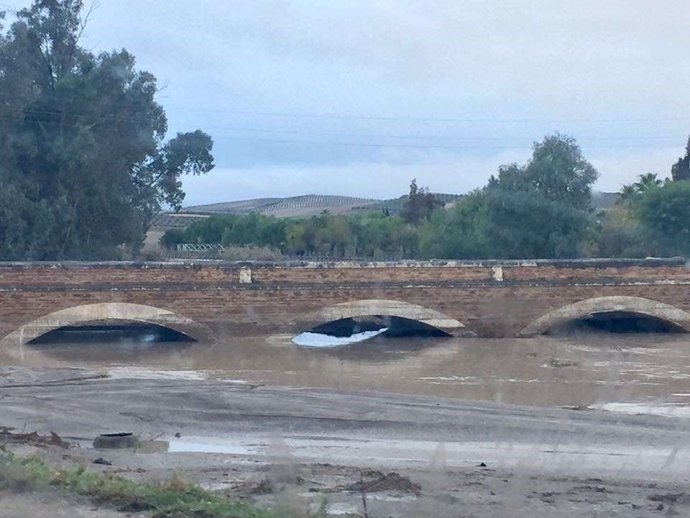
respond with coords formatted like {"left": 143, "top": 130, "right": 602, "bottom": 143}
{"left": 0, "top": 258, "right": 690, "bottom": 345}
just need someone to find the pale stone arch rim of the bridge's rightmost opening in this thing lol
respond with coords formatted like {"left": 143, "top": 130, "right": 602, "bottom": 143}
{"left": 518, "top": 296, "right": 690, "bottom": 337}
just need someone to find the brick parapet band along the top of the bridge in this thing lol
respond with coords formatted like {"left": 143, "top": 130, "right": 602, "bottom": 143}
{"left": 0, "top": 258, "right": 690, "bottom": 290}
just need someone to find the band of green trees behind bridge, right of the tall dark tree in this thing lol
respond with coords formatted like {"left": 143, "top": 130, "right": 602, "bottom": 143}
{"left": 160, "top": 136, "right": 690, "bottom": 260}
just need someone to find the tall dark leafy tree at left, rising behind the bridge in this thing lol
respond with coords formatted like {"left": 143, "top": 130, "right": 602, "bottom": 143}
{"left": 0, "top": 0, "right": 213, "bottom": 259}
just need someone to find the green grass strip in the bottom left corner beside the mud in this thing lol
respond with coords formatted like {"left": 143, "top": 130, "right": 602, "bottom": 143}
{"left": 0, "top": 447, "right": 326, "bottom": 518}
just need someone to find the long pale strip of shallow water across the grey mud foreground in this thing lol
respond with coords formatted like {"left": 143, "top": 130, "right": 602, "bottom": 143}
{"left": 150, "top": 436, "right": 690, "bottom": 480}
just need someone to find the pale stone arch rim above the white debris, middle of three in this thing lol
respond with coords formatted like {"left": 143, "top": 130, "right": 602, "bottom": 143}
{"left": 303, "top": 299, "right": 464, "bottom": 336}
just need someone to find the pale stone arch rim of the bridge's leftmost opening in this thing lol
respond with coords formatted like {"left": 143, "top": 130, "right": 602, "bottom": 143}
{"left": 0, "top": 302, "right": 211, "bottom": 345}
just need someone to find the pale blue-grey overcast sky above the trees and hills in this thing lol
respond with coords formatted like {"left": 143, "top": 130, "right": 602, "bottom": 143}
{"left": 0, "top": 0, "right": 690, "bottom": 205}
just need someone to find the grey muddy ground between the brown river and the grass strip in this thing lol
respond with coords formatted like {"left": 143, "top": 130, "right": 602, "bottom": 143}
{"left": 0, "top": 367, "right": 690, "bottom": 517}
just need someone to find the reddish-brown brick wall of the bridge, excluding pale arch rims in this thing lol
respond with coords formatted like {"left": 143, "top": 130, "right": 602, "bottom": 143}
{"left": 0, "top": 259, "right": 690, "bottom": 337}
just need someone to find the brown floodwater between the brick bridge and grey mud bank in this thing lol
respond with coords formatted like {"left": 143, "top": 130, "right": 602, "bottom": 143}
{"left": 5, "top": 332, "right": 690, "bottom": 416}
